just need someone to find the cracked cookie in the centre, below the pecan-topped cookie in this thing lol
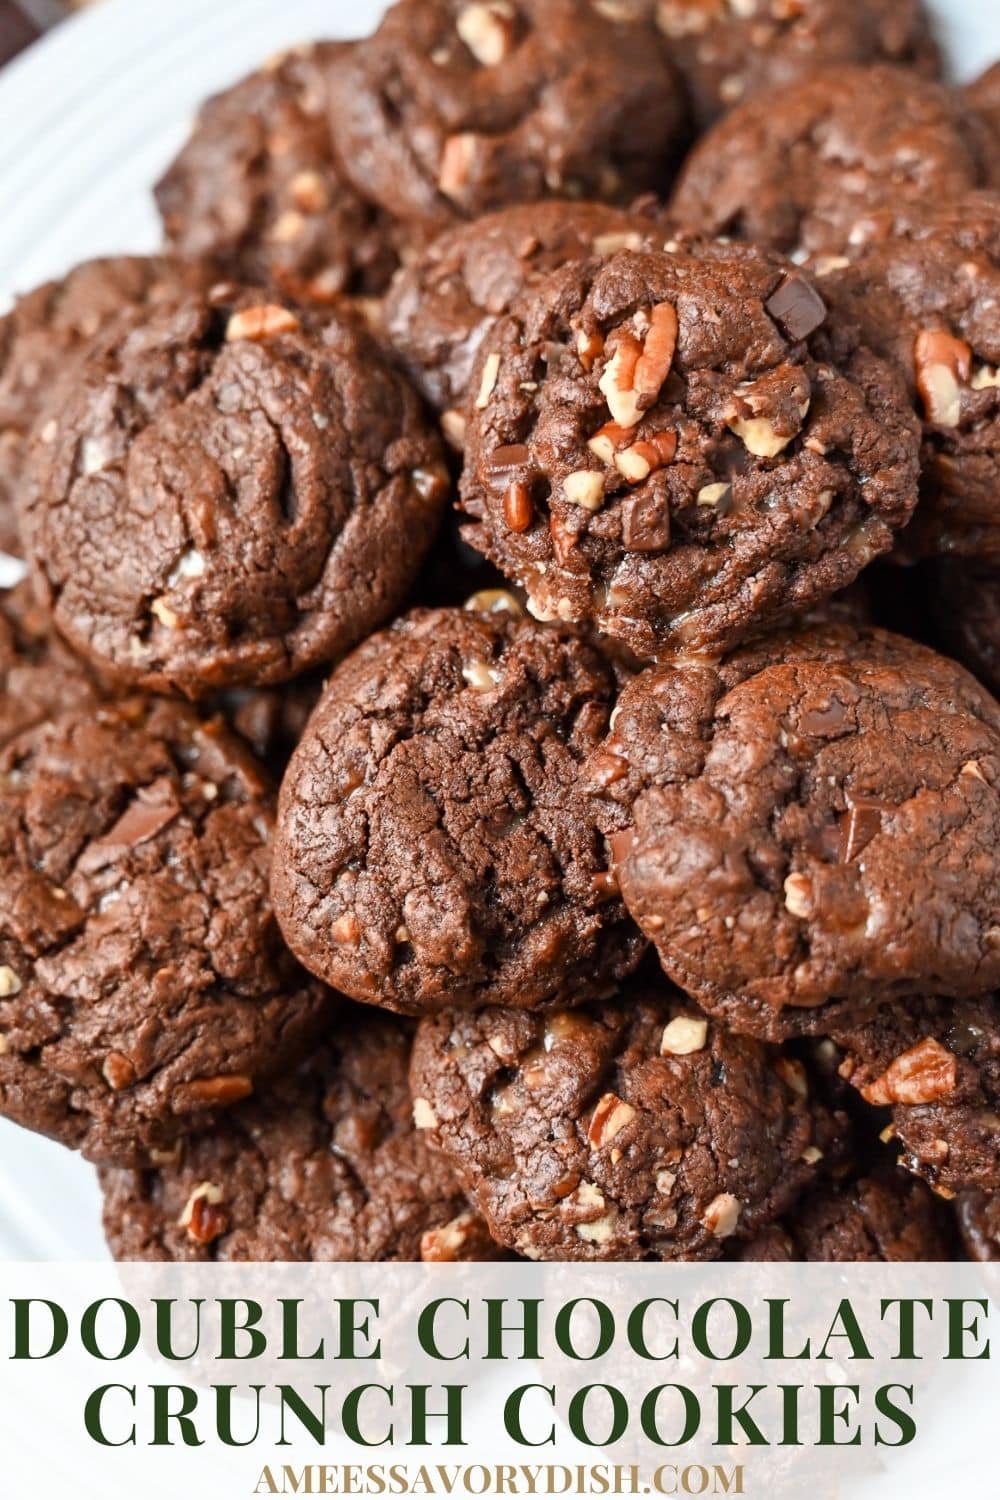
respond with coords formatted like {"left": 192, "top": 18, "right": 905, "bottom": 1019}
{"left": 273, "top": 609, "right": 645, "bottom": 1014}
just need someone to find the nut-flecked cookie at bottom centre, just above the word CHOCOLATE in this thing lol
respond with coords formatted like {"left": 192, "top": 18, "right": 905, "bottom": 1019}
{"left": 411, "top": 986, "right": 831, "bottom": 1260}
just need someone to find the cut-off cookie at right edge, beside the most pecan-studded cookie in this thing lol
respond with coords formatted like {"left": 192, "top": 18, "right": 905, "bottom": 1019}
{"left": 822, "top": 192, "right": 1000, "bottom": 566}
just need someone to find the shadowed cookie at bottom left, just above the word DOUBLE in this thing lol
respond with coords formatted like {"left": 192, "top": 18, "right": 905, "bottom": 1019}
{"left": 102, "top": 1008, "right": 499, "bottom": 1262}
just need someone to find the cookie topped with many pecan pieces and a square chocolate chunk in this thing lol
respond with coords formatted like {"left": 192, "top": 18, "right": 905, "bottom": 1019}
{"left": 462, "top": 245, "right": 918, "bottom": 657}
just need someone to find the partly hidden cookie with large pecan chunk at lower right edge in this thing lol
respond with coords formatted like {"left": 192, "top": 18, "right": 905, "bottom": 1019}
{"left": 832, "top": 996, "right": 1000, "bottom": 1196}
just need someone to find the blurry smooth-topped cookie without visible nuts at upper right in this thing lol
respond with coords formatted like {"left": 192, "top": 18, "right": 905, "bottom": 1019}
{"left": 670, "top": 66, "right": 997, "bottom": 255}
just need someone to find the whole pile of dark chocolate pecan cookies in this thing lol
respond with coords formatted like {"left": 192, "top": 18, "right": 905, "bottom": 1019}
{"left": 0, "top": 0, "right": 1000, "bottom": 1260}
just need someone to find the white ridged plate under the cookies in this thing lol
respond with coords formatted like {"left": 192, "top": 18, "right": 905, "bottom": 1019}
{"left": 0, "top": 0, "right": 1000, "bottom": 1260}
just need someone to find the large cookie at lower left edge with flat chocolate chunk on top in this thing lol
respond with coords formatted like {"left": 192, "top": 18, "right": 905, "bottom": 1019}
{"left": 0, "top": 699, "right": 327, "bottom": 1164}
